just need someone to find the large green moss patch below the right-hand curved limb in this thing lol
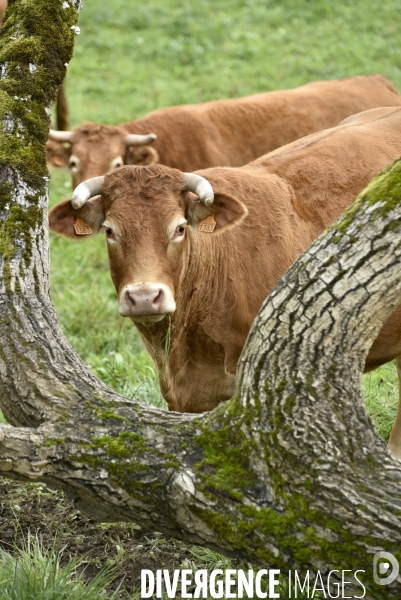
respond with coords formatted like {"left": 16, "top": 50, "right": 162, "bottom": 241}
{"left": 190, "top": 381, "right": 401, "bottom": 598}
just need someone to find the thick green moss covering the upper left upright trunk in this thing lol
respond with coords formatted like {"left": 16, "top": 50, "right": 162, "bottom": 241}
{"left": 0, "top": 0, "right": 78, "bottom": 274}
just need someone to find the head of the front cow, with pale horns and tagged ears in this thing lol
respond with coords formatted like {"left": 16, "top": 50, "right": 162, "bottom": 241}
{"left": 49, "top": 165, "right": 247, "bottom": 324}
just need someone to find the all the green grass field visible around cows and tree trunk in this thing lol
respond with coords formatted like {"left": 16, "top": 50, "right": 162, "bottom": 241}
{"left": 0, "top": 0, "right": 401, "bottom": 598}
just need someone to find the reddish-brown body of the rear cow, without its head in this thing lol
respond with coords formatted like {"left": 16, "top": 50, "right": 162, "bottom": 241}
{"left": 123, "top": 75, "right": 401, "bottom": 171}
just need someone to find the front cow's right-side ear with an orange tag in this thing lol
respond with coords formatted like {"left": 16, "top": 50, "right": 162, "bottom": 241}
{"left": 186, "top": 192, "right": 248, "bottom": 233}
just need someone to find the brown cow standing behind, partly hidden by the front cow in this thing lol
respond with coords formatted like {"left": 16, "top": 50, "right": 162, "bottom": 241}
{"left": 50, "top": 75, "right": 401, "bottom": 187}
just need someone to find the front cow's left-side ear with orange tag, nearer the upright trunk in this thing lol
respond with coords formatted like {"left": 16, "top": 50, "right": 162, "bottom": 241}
{"left": 49, "top": 196, "right": 105, "bottom": 240}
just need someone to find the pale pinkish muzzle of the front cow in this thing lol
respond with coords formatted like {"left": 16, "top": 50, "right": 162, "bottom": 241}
{"left": 119, "top": 283, "right": 176, "bottom": 323}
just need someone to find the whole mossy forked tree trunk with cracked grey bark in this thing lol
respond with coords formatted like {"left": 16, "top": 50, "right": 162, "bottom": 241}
{"left": 0, "top": 0, "right": 401, "bottom": 598}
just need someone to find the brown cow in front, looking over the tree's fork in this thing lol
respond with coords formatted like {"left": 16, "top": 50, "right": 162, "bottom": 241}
{"left": 50, "top": 107, "right": 401, "bottom": 456}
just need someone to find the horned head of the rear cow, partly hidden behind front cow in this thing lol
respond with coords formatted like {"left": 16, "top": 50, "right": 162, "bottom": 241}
{"left": 49, "top": 123, "right": 159, "bottom": 187}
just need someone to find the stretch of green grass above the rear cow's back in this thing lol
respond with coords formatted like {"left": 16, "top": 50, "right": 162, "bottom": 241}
{"left": 68, "top": 0, "right": 401, "bottom": 124}
